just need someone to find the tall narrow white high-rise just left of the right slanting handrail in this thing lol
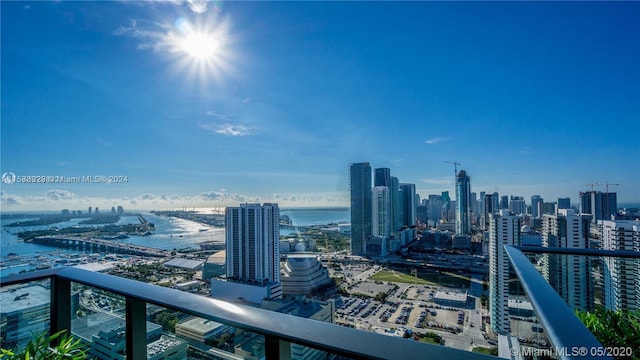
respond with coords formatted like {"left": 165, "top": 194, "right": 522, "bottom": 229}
{"left": 489, "top": 209, "right": 521, "bottom": 334}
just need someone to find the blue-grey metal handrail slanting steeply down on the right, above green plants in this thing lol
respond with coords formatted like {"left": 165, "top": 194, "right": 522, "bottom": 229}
{"left": 504, "top": 245, "right": 613, "bottom": 359}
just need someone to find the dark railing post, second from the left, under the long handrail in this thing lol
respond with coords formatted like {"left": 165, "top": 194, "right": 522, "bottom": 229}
{"left": 126, "top": 297, "right": 147, "bottom": 360}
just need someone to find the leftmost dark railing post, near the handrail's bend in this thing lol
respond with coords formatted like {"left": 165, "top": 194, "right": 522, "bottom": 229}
{"left": 49, "top": 276, "right": 71, "bottom": 345}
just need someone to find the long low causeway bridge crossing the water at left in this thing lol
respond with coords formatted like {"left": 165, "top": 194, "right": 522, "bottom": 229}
{"left": 30, "top": 236, "right": 172, "bottom": 257}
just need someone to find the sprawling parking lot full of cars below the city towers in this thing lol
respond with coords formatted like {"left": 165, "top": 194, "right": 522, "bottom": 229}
{"left": 334, "top": 264, "right": 547, "bottom": 350}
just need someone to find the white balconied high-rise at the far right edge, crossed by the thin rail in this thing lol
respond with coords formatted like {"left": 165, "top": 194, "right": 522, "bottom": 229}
{"left": 598, "top": 220, "right": 640, "bottom": 310}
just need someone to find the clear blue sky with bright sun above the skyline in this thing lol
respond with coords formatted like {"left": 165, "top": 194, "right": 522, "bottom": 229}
{"left": 0, "top": 0, "right": 640, "bottom": 211}
